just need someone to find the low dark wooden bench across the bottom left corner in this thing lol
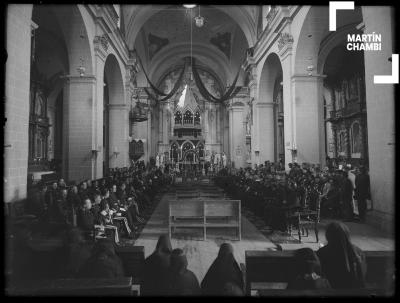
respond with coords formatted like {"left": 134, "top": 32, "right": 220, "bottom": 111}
{"left": 6, "top": 277, "right": 133, "bottom": 296}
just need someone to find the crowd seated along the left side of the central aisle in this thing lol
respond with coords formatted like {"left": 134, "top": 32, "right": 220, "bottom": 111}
{"left": 23, "top": 168, "right": 170, "bottom": 242}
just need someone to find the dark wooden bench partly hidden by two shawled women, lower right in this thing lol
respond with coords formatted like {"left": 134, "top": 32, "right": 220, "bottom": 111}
{"left": 245, "top": 250, "right": 394, "bottom": 295}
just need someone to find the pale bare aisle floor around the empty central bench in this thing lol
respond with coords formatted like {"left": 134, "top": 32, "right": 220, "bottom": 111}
{"left": 135, "top": 184, "right": 276, "bottom": 283}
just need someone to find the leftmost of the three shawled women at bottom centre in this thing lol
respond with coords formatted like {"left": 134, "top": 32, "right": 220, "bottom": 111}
{"left": 142, "top": 235, "right": 172, "bottom": 296}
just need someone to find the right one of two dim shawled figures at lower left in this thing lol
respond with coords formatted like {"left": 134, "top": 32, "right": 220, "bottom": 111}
{"left": 78, "top": 239, "right": 124, "bottom": 279}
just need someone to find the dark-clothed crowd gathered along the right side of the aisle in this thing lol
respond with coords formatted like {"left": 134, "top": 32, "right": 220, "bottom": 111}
{"left": 215, "top": 161, "right": 370, "bottom": 231}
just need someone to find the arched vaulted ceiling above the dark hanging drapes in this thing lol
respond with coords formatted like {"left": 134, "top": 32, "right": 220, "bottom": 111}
{"left": 122, "top": 5, "right": 259, "bottom": 87}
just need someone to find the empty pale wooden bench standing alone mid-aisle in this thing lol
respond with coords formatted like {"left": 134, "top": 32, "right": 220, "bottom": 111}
{"left": 168, "top": 199, "right": 241, "bottom": 240}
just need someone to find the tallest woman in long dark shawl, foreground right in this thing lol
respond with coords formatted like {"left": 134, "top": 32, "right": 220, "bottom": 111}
{"left": 317, "top": 221, "right": 366, "bottom": 288}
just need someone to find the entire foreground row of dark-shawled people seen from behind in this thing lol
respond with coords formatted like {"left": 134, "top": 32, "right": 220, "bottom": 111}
{"left": 9, "top": 221, "right": 376, "bottom": 296}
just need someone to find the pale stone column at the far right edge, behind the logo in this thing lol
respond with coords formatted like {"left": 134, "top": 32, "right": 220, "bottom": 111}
{"left": 362, "top": 6, "right": 398, "bottom": 231}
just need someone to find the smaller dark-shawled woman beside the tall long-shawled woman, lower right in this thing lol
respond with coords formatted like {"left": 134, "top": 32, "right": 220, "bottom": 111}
{"left": 287, "top": 247, "right": 331, "bottom": 290}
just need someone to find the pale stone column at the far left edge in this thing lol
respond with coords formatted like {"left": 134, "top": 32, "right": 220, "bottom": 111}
{"left": 3, "top": 4, "right": 33, "bottom": 203}
